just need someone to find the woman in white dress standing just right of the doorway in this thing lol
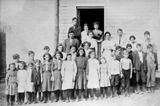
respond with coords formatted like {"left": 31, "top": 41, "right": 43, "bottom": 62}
{"left": 101, "top": 32, "right": 115, "bottom": 62}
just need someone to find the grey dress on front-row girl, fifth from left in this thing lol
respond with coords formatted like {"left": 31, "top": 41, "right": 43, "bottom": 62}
{"left": 42, "top": 62, "right": 53, "bottom": 92}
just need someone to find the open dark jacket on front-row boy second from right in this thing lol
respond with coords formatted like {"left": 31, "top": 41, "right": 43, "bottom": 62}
{"left": 133, "top": 50, "right": 147, "bottom": 71}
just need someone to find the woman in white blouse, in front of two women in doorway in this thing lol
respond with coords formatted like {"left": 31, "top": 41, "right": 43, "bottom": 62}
{"left": 87, "top": 31, "right": 97, "bottom": 54}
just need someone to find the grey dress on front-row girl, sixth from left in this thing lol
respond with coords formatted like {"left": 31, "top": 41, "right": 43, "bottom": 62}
{"left": 52, "top": 60, "right": 62, "bottom": 91}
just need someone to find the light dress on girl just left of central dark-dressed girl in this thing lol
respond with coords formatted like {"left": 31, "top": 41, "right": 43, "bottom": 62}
{"left": 61, "top": 61, "right": 77, "bottom": 90}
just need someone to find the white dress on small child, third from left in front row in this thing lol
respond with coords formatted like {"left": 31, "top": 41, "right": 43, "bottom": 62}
{"left": 27, "top": 69, "right": 33, "bottom": 92}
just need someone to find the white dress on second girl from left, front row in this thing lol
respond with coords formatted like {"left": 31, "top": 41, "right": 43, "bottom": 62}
{"left": 17, "top": 70, "right": 27, "bottom": 93}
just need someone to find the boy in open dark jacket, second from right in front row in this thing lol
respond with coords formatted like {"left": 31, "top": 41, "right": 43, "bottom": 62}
{"left": 133, "top": 43, "right": 146, "bottom": 93}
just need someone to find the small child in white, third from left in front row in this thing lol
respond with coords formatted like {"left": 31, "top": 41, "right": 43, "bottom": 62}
{"left": 27, "top": 63, "right": 34, "bottom": 104}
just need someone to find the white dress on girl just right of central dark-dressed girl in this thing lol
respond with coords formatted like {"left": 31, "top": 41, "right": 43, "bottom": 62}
{"left": 87, "top": 59, "right": 100, "bottom": 89}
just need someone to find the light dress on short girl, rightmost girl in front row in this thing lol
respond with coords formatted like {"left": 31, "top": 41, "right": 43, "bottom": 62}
{"left": 100, "top": 64, "right": 111, "bottom": 87}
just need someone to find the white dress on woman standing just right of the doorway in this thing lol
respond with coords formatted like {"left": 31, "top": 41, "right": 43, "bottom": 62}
{"left": 101, "top": 40, "right": 115, "bottom": 61}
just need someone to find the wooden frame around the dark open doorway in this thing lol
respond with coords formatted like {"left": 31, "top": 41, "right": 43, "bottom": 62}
{"left": 76, "top": 6, "right": 105, "bottom": 31}
